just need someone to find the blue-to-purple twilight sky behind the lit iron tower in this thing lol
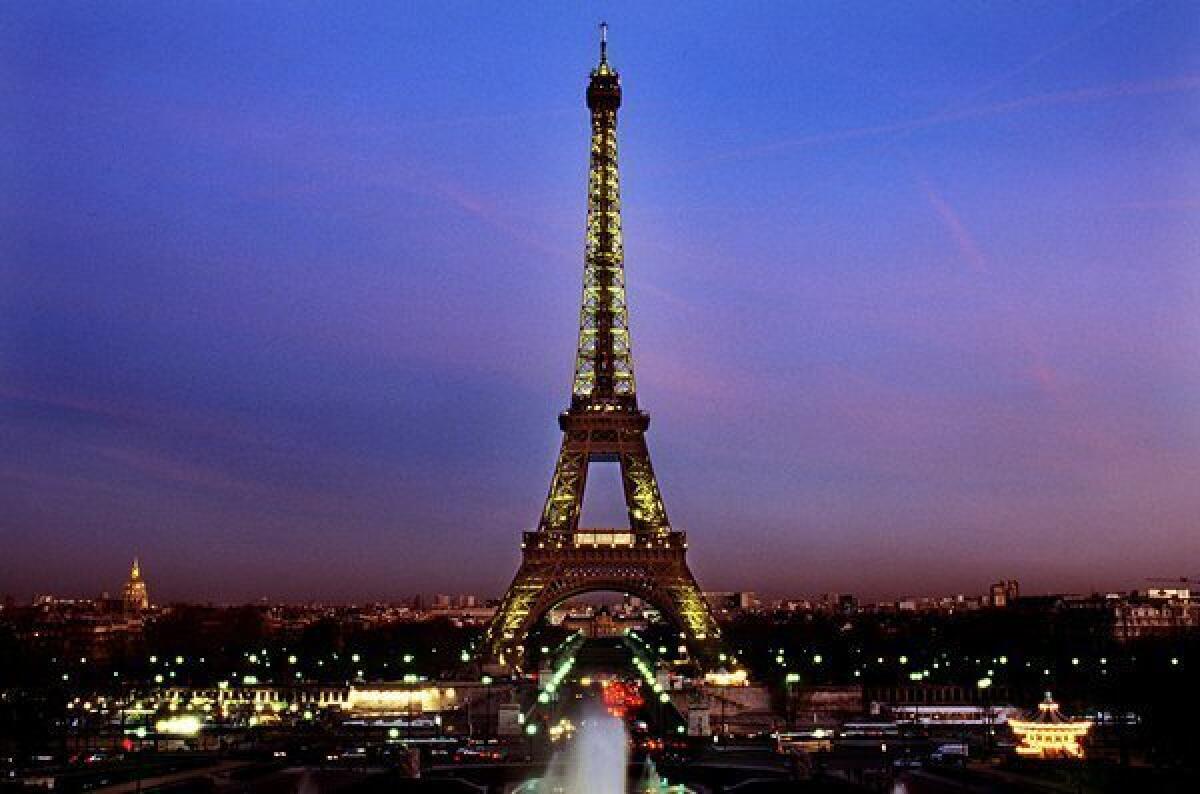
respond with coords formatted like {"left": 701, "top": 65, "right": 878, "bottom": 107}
{"left": 0, "top": 0, "right": 1200, "bottom": 600}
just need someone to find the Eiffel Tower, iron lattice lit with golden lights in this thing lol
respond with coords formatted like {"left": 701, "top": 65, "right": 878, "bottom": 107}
{"left": 482, "top": 25, "right": 720, "bottom": 669}
